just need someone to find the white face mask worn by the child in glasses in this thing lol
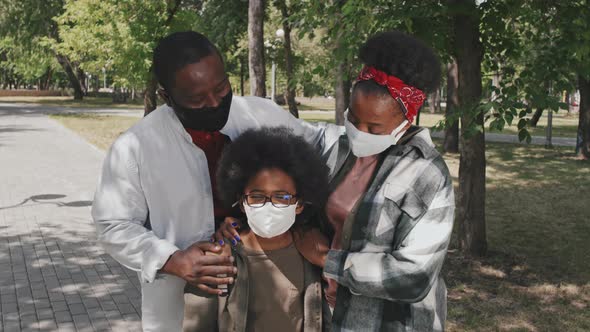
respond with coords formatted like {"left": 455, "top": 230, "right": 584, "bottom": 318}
{"left": 242, "top": 202, "right": 297, "bottom": 238}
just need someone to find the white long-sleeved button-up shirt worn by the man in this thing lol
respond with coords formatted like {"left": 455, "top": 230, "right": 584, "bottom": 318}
{"left": 92, "top": 96, "right": 337, "bottom": 331}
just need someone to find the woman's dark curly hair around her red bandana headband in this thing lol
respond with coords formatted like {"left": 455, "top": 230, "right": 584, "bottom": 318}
{"left": 357, "top": 31, "right": 441, "bottom": 93}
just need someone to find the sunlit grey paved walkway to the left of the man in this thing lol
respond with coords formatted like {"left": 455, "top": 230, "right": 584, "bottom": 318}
{"left": 0, "top": 105, "right": 141, "bottom": 332}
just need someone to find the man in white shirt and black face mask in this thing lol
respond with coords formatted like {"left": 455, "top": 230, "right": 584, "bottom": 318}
{"left": 92, "top": 31, "right": 336, "bottom": 331}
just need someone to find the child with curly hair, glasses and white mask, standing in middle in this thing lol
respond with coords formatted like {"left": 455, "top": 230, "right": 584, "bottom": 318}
{"left": 188, "top": 128, "right": 329, "bottom": 332}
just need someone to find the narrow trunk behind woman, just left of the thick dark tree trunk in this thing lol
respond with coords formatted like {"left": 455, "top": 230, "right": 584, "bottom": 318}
{"left": 443, "top": 59, "right": 459, "bottom": 153}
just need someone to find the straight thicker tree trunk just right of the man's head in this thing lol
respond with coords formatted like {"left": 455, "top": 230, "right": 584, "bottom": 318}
{"left": 248, "top": 0, "right": 266, "bottom": 97}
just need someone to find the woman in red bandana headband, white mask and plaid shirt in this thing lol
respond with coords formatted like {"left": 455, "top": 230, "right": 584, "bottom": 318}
{"left": 217, "top": 31, "right": 454, "bottom": 331}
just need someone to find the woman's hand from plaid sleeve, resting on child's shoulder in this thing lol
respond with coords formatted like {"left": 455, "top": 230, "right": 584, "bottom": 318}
{"left": 293, "top": 228, "right": 330, "bottom": 268}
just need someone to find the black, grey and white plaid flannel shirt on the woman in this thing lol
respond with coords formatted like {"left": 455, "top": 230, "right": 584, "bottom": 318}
{"left": 322, "top": 127, "right": 455, "bottom": 331}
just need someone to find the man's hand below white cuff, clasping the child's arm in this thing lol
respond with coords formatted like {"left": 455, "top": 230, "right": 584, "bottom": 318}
{"left": 160, "top": 242, "right": 238, "bottom": 295}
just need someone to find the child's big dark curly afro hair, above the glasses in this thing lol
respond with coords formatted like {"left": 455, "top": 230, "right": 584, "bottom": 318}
{"left": 217, "top": 127, "right": 328, "bottom": 223}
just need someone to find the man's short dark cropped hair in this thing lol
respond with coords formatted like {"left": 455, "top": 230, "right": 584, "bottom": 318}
{"left": 153, "top": 31, "right": 221, "bottom": 90}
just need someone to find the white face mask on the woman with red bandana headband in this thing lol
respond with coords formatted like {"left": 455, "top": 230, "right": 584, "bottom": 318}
{"left": 344, "top": 110, "right": 408, "bottom": 158}
